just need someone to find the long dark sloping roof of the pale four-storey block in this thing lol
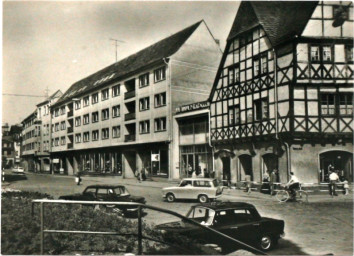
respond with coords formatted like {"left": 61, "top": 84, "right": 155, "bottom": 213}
{"left": 54, "top": 21, "right": 203, "bottom": 105}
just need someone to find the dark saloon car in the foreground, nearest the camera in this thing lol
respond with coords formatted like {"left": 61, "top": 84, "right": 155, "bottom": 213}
{"left": 156, "top": 202, "right": 284, "bottom": 251}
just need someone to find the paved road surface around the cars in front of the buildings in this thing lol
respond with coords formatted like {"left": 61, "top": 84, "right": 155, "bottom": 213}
{"left": 2, "top": 174, "right": 353, "bottom": 255}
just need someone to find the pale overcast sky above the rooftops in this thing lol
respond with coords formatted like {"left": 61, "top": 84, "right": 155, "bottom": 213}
{"left": 2, "top": 1, "right": 239, "bottom": 124}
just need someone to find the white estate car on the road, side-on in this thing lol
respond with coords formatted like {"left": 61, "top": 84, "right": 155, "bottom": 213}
{"left": 162, "top": 178, "right": 222, "bottom": 203}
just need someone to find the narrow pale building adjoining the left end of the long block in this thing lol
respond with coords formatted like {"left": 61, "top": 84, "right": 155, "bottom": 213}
{"left": 35, "top": 90, "right": 63, "bottom": 172}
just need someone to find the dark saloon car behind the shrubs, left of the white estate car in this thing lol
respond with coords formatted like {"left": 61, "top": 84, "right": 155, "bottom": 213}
{"left": 59, "top": 185, "right": 146, "bottom": 215}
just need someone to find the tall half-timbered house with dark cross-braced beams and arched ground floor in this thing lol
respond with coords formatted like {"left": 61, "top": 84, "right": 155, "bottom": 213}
{"left": 210, "top": 1, "right": 354, "bottom": 183}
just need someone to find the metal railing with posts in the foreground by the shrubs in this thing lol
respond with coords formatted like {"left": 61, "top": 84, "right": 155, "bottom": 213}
{"left": 31, "top": 199, "right": 266, "bottom": 255}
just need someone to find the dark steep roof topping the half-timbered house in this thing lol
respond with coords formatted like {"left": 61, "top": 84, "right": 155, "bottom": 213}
{"left": 228, "top": 1, "right": 318, "bottom": 46}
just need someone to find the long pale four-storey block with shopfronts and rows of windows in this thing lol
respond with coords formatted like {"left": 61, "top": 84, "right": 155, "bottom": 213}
{"left": 51, "top": 21, "right": 221, "bottom": 177}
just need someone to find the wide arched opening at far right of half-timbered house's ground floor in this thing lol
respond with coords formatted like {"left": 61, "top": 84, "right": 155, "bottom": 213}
{"left": 319, "top": 150, "right": 353, "bottom": 182}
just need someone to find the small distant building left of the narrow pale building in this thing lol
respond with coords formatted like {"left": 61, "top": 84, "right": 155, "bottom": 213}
{"left": 21, "top": 110, "right": 41, "bottom": 171}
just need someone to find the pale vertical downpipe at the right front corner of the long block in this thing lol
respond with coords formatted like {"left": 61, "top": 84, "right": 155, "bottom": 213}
{"left": 162, "top": 58, "right": 174, "bottom": 180}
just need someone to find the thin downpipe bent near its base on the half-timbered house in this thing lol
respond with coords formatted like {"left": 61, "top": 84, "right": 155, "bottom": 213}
{"left": 273, "top": 48, "right": 291, "bottom": 178}
